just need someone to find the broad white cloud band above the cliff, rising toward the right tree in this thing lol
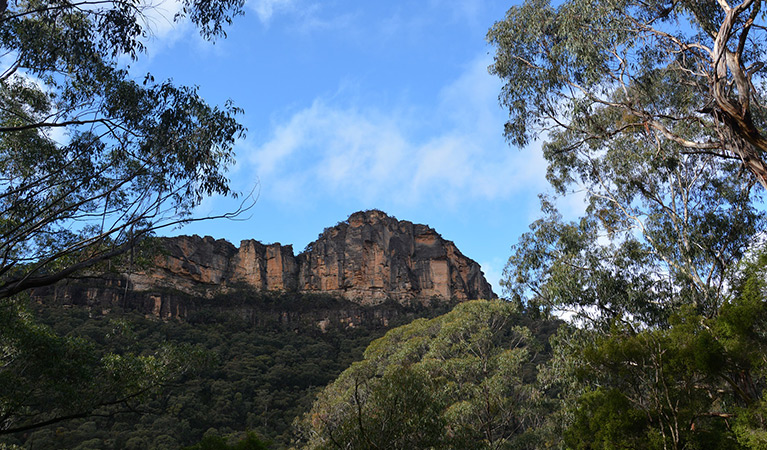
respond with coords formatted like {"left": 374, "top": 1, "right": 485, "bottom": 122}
{"left": 239, "top": 58, "right": 545, "bottom": 206}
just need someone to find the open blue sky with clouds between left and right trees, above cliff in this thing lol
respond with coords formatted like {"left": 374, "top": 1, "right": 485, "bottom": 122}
{"left": 136, "top": 0, "right": 576, "bottom": 294}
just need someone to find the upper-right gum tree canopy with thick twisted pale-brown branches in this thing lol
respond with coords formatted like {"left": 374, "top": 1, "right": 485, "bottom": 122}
{"left": 489, "top": 0, "right": 767, "bottom": 187}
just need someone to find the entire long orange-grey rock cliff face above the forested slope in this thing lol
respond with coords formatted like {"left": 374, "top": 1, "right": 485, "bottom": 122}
{"left": 129, "top": 210, "right": 495, "bottom": 306}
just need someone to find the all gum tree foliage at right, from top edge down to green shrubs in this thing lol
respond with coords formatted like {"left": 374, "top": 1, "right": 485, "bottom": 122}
{"left": 488, "top": 0, "right": 767, "bottom": 321}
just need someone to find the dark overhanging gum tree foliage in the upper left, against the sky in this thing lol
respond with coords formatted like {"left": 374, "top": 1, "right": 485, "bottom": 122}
{"left": 0, "top": 0, "right": 244, "bottom": 297}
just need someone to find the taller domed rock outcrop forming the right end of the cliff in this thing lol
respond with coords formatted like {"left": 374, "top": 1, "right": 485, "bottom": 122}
{"left": 297, "top": 210, "right": 495, "bottom": 304}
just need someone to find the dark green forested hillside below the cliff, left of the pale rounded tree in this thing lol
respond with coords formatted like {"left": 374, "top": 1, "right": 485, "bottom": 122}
{"left": 0, "top": 293, "right": 456, "bottom": 449}
